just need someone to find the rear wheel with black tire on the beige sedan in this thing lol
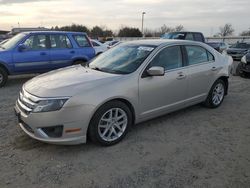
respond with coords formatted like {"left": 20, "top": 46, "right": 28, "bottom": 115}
{"left": 205, "top": 79, "right": 226, "bottom": 108}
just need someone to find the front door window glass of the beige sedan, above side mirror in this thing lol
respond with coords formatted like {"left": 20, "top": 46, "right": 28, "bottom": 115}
{"left": 150, "top": 46, "right": 182, "bottom": 70}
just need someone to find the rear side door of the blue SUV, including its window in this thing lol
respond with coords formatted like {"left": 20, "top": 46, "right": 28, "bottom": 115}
{"left": 49, "top": 34, "right": 73, "bottom": 69}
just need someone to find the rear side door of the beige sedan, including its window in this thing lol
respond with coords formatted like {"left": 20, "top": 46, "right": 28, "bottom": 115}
{"left": 185, "top": 45, "right": 219, "bottom": 103}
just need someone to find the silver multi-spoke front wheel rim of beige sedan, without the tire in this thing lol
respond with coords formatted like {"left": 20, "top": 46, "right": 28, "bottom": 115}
{"left": 98, "top": 108, "right": 128, "bottom": 142}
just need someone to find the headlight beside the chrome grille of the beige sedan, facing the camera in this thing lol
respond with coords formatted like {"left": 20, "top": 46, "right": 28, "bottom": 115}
{"left": 32, "top": 98, "right": 68, "bottom": 113}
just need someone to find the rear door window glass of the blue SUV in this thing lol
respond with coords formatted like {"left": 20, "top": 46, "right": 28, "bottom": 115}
{"left": 50, "top": 35, "right": 72, "bottom": 49}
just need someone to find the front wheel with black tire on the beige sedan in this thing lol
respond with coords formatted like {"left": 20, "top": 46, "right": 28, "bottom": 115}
{"left": 88, "top": 101, "right": 132, "bottom": 146}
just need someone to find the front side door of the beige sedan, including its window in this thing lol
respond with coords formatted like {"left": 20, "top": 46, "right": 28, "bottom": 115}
{"left": 139, "top": 46, "right": 187, "bottom": 118}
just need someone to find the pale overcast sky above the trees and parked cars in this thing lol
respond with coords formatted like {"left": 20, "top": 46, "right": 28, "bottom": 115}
{"left": 0, "top": 0, "right": 250, "bottom": 36}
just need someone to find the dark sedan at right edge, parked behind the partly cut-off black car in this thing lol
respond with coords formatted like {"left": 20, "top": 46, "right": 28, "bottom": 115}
{"left": 227, "top": 42, "right": 250, "bottom": 61}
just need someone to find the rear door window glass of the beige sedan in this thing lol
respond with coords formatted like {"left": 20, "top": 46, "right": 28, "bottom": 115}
{"left": 186, "top": 46, "right": 209, "bottom": 65}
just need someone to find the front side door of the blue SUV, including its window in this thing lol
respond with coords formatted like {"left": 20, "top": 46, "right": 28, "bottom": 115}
{"left": 13, "top": 34, "right": 50, "bottom": 73}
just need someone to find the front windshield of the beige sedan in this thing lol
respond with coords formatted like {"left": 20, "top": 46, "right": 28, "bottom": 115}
{"left": 89, "top": 44, "right": 155, "bottom": 74}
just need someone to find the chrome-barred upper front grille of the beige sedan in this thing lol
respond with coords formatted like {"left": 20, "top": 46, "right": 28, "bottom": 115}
{"left": 17, "top": 89, "right": 38, "bottom": 114}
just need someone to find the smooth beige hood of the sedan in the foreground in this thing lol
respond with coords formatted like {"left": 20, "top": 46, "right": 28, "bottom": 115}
{"left": 23, "top": 65, "right": 121, "bottom": 97}
